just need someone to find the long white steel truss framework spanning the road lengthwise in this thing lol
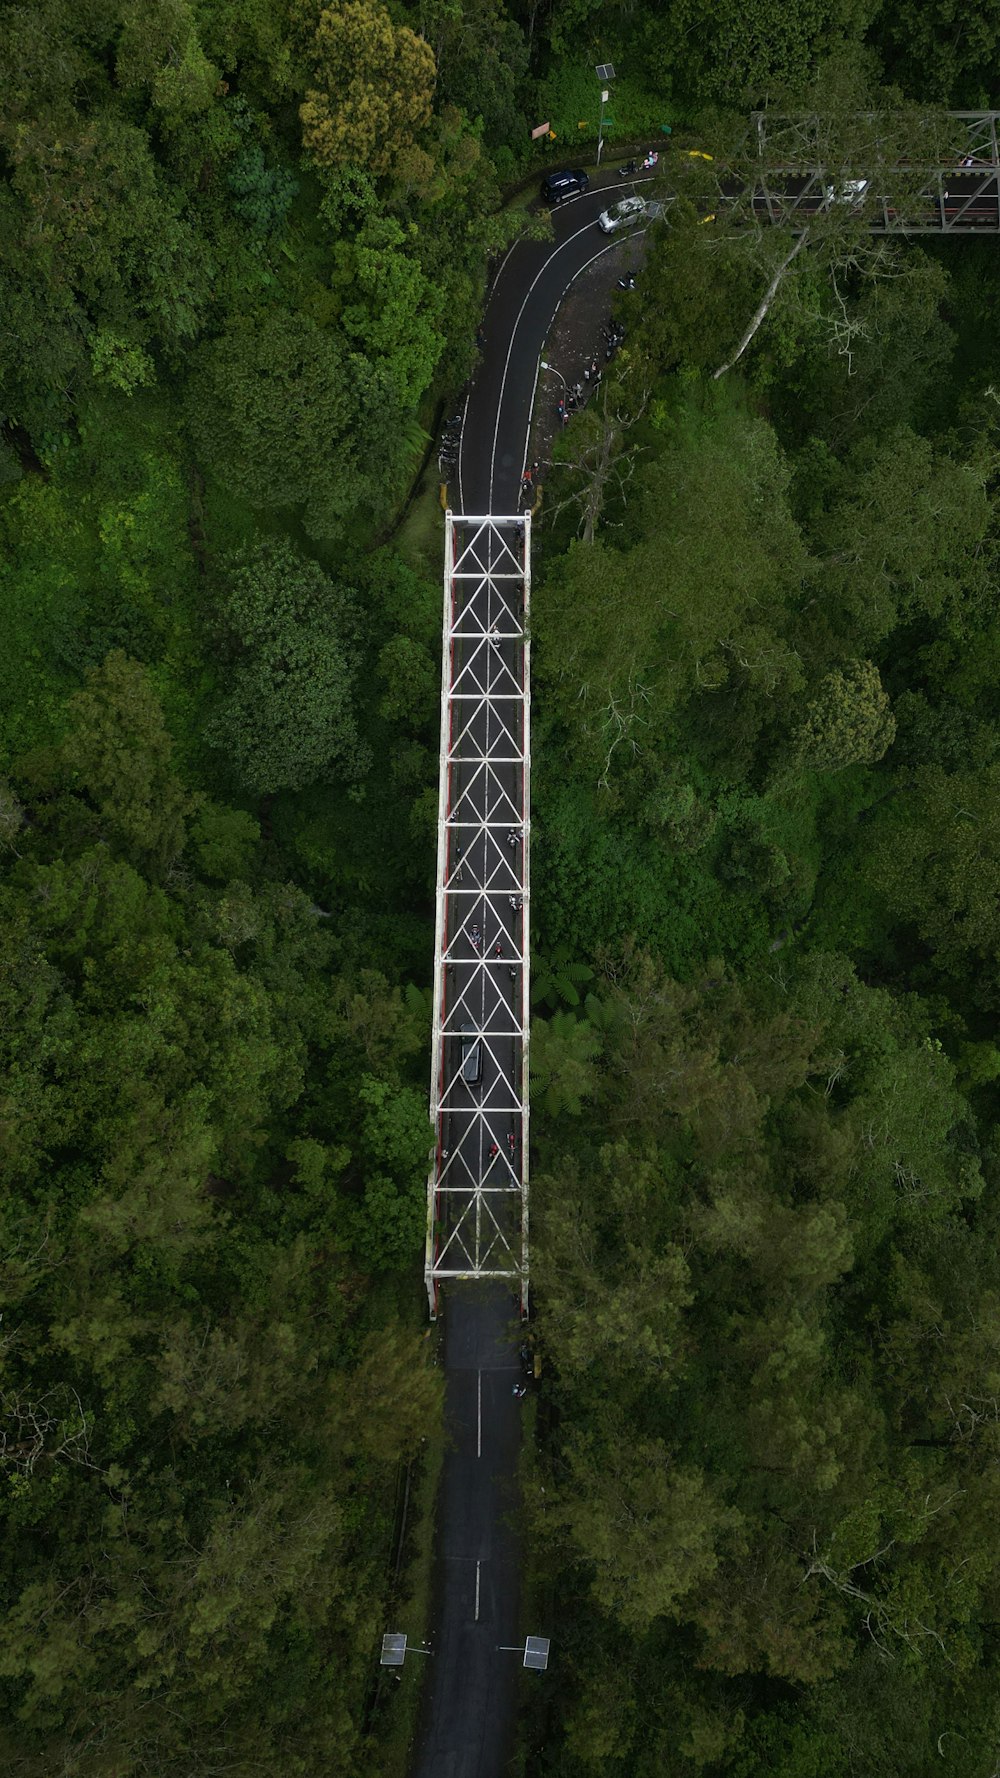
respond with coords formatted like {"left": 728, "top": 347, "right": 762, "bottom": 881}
{"left": 425, "top": 512, "right": 530, "bottom": 1317}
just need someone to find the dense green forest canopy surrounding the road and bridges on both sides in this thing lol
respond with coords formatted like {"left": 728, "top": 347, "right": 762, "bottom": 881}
{"left": 0, "top": 0, "right": 1000, "bottom": 1778}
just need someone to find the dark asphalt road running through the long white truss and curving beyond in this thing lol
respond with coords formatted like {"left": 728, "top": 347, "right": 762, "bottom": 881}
{"left": 413, "top": 169, "right": 635, "bottom": 1778}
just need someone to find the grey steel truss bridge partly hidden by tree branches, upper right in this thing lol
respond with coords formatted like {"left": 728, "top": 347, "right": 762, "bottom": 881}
{"left": 694, "top": 110, "right": 1000, "bottom": 235}
